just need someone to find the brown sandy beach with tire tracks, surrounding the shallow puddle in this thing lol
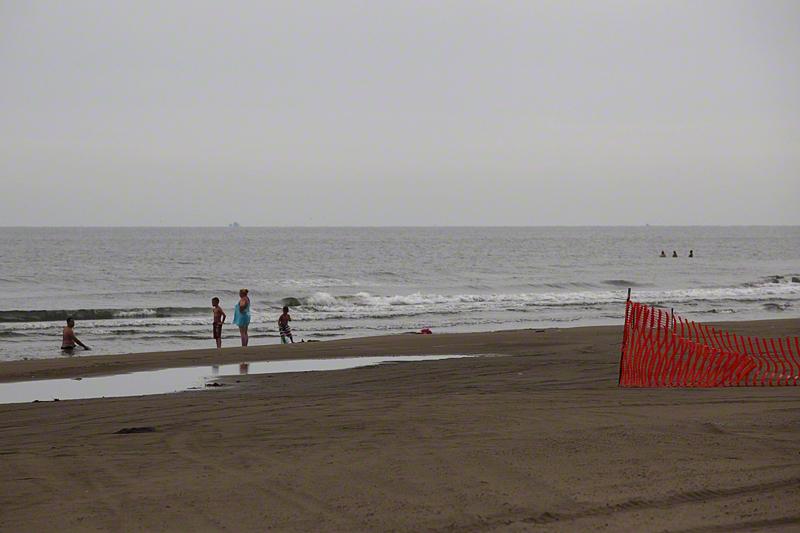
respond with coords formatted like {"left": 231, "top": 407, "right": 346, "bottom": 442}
{"left": 0, "top": 320, "right": 800, "bottom": 532}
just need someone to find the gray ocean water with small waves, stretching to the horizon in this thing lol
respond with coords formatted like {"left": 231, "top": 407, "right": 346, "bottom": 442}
{"left": 0, "top": 227, "right": 800, "bottom": 360}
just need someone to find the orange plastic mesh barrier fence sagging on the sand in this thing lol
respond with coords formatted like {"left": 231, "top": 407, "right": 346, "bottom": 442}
{"left": 619, "top": 299, "right": 800, "bottom": 387}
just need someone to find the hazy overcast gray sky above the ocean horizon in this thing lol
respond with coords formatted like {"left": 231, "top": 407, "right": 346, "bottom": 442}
{"left": 0, "top": 0, "right": 800, "bottom": 225}
